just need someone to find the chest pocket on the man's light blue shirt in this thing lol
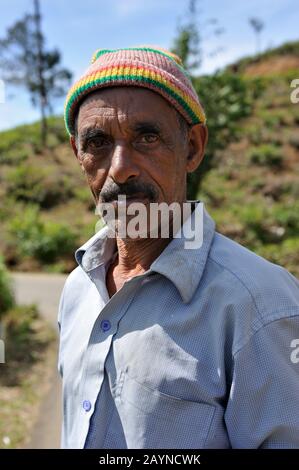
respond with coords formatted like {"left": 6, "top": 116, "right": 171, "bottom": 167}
{"left": 119, "top": 374, "right": 215, "bottom": 449}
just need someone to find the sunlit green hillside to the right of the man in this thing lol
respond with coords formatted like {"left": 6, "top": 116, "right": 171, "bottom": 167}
{"left": 201, "top": 41, "right": 299, "bottom": 277}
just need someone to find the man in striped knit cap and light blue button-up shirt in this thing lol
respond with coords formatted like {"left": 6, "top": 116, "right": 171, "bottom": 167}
{"left": 59, "top": 47, "right": 299, "bottom": 448}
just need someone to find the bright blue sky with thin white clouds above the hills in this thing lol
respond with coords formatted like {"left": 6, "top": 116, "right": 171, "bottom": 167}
{"left": 0, "top": 0, "right": 299, "bottom": 130}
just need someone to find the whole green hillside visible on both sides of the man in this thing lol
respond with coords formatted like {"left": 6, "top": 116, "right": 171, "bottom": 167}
{"left": 0, "top": 42, "right": 299, "bottom": 276}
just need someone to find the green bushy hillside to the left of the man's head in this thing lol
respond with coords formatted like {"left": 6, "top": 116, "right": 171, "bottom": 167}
{"left": 0, "top": 117, "right": 97, "bottom": 272}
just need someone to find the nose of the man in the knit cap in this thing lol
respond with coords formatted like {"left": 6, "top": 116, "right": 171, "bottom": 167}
{"left": 109, "top": 143, "right": 140, "bottom": 183}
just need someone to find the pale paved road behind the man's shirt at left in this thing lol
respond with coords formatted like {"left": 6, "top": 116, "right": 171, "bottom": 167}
{"left": 12, "top": 273, "right": 66, "bottom": 449}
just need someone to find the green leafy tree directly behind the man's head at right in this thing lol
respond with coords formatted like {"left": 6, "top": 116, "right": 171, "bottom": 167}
{"left": 173, "top": 0, "right": 255, "bottom": 199}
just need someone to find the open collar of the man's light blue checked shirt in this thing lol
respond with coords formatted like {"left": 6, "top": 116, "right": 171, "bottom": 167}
{"left": 75, "top": 200, "right": 215, "bottom": 303}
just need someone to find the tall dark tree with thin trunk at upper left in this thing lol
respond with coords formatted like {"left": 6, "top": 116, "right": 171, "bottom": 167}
{"left": 0, "top": 0, "right": 72, "bottom": 145}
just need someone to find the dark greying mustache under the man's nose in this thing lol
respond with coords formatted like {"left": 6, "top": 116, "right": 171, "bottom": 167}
{"left": 99, "top": 180, "right": 159, "bottom": 203}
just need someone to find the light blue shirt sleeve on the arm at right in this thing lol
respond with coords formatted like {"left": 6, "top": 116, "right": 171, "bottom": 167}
{"left": 225, "top": 307, "right": 299, "bottom": 449}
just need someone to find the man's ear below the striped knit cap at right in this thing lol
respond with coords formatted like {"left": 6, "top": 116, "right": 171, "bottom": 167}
{"left": 186, "top": 124, "right": 208, "bottom": 173}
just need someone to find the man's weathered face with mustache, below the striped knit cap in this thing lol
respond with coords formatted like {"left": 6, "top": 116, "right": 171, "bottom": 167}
{"left": 71, "top": 87, "right": 207, "bottom": 213}
